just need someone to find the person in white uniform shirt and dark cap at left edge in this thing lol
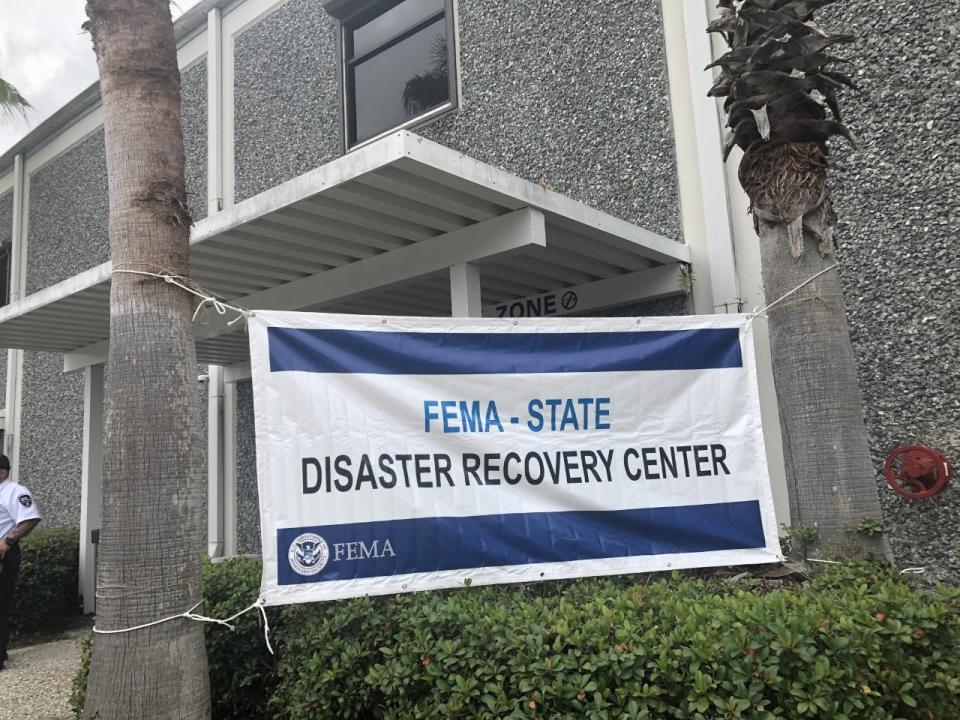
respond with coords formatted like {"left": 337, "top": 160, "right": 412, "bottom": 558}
{"left": 0, "top": 455, "right": 40, "bottom": 670}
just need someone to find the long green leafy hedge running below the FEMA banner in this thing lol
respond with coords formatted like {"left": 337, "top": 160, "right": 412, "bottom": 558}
{"left": 73, "top": 560, "right": 960, "bottom": 720}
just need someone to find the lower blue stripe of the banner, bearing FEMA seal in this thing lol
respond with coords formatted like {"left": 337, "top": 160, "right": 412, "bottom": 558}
{"left": 277, "top": 500, "right": 764, "bottom": 585}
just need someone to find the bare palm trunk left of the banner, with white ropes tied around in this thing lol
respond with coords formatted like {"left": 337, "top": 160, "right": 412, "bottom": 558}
{"left": 85, "top": 0, "right": 210, "bottom": 720}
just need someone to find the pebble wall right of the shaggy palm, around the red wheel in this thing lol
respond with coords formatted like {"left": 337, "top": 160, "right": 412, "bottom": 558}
{"left": 820, "top": 0, "right": 960, "bottom": 579}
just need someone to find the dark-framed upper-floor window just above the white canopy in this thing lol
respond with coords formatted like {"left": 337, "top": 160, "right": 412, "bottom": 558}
{"left": 343, "top": 0, "right": 456, "bottom": 147}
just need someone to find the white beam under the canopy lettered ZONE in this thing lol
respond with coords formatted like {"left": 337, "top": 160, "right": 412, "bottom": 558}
{"left": 483, "top": 263, "right": 686, "bottom": 317}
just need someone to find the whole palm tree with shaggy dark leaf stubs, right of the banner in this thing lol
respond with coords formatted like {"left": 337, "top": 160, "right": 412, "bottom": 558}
{"left": 708, "top": 0, "right": 880, "bottom": 552}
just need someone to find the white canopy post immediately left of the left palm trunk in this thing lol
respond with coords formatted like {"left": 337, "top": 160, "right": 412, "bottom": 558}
{"left": 80, "top": 364, "right": 104, "bottom": 613}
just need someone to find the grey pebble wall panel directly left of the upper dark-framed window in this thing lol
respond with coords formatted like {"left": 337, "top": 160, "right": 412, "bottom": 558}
{"left": 234, "top": 0, "right": 342, "bottom": 202}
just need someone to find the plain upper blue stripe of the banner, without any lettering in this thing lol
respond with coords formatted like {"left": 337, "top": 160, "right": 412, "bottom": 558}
{"left": 267, "top": 327, "right": 743, "bottom": 375}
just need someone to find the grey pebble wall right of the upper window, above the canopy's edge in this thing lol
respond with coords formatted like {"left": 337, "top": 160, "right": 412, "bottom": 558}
{"left": 414, "top": 0, "right": 680, "bottom": 239}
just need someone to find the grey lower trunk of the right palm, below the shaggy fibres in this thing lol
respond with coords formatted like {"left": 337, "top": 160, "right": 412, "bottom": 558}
{"left": 757, "top": 217, "right": 881, "bottom": 553}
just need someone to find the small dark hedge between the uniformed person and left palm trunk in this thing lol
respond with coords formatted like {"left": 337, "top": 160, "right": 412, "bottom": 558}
{"left": 12, "top": 527, "right": 80, "bottom": 636}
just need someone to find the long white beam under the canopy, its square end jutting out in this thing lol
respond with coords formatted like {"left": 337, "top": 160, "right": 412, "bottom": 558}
{"left": 196, "top": 208, "right": 547, "bottom": 340}
